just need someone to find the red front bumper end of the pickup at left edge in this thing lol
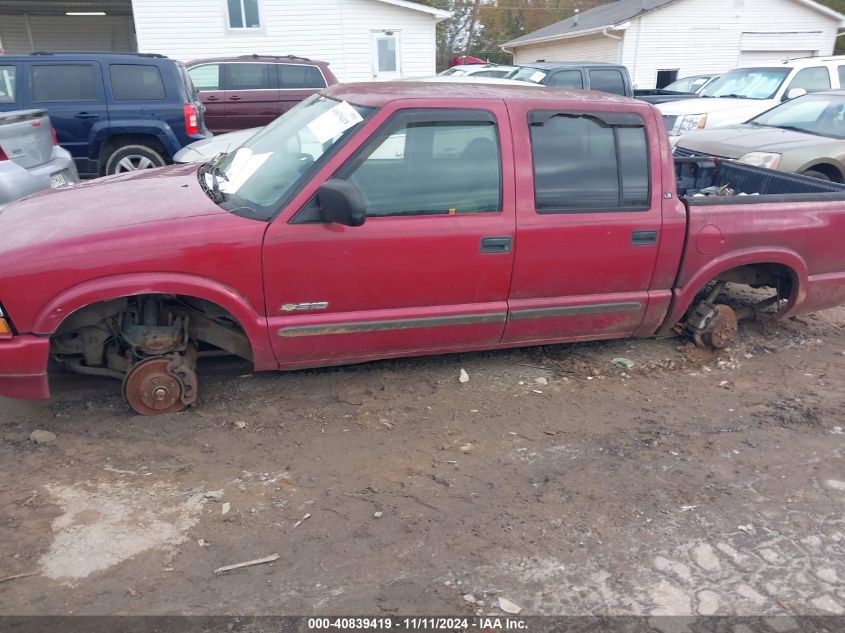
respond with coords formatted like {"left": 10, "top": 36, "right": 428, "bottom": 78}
{"left": 0, "top": 335, "right": 50, "bottom": 400}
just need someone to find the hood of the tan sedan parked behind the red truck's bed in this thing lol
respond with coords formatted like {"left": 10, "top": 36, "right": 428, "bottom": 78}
{"left": 678, "top": 125, "right": 842, "bottom": 158}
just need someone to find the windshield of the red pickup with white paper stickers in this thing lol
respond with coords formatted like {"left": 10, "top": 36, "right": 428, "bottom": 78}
{"left": 197, "top": 95, "right": 374, "bottom": 220}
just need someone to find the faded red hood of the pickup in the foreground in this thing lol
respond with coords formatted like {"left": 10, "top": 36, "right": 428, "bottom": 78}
{"left": 0, "top": 165, "right": 227, "bottom": 252}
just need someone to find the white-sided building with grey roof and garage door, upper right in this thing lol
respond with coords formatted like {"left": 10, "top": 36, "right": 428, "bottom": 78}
{"left": 502, "top": 0, "right": 845, "bottom": 88}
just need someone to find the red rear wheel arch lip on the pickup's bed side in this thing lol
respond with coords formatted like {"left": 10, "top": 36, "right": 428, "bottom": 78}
{"left": 658, "top": 248, "right": 808, "bottom": 335}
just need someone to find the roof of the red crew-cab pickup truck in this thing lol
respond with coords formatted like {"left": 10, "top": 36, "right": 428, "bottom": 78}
{"left": 321, "top": 81, "right": 640, "bottom": 108}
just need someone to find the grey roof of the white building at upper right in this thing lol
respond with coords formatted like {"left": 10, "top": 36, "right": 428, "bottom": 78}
{"left": 502, "top": 0, "right": 845, "bottom": 49}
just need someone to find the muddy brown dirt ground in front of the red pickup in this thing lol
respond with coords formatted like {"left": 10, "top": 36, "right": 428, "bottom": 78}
{"left": 0, "top": 308, "right": 845, "bottom": 615}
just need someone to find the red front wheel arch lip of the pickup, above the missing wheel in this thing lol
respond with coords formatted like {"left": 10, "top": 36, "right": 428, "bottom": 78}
{"left": 32, "top": 273, "right": 278, "bottom": 370}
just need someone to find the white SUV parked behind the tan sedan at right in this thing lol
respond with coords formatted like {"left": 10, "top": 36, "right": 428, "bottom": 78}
{"left": 658, "top": 56, "right": 845, "bottom": 141}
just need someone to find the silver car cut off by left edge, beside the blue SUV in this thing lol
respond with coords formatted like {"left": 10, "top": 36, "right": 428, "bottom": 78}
{"left": 0, "top": 110, "right": 79, "bottom": 209}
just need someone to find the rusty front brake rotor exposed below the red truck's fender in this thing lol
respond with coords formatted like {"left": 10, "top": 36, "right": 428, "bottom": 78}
{"left": 123, "top": 358, "right": 185, "bottom": 415}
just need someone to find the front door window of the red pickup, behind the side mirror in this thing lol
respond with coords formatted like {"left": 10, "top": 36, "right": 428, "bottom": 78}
{"left": 338, "top": 110, "right": 501, "bottom": 217}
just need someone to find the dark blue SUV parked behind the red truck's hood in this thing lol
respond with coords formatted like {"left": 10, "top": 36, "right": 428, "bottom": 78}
{"left": 0, "top": 53, "right": 207, "bottom": 176}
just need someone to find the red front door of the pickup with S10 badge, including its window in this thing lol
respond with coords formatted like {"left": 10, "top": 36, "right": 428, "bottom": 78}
{"left": 264, "top": 101, "right": 515, "bottom": 368}
